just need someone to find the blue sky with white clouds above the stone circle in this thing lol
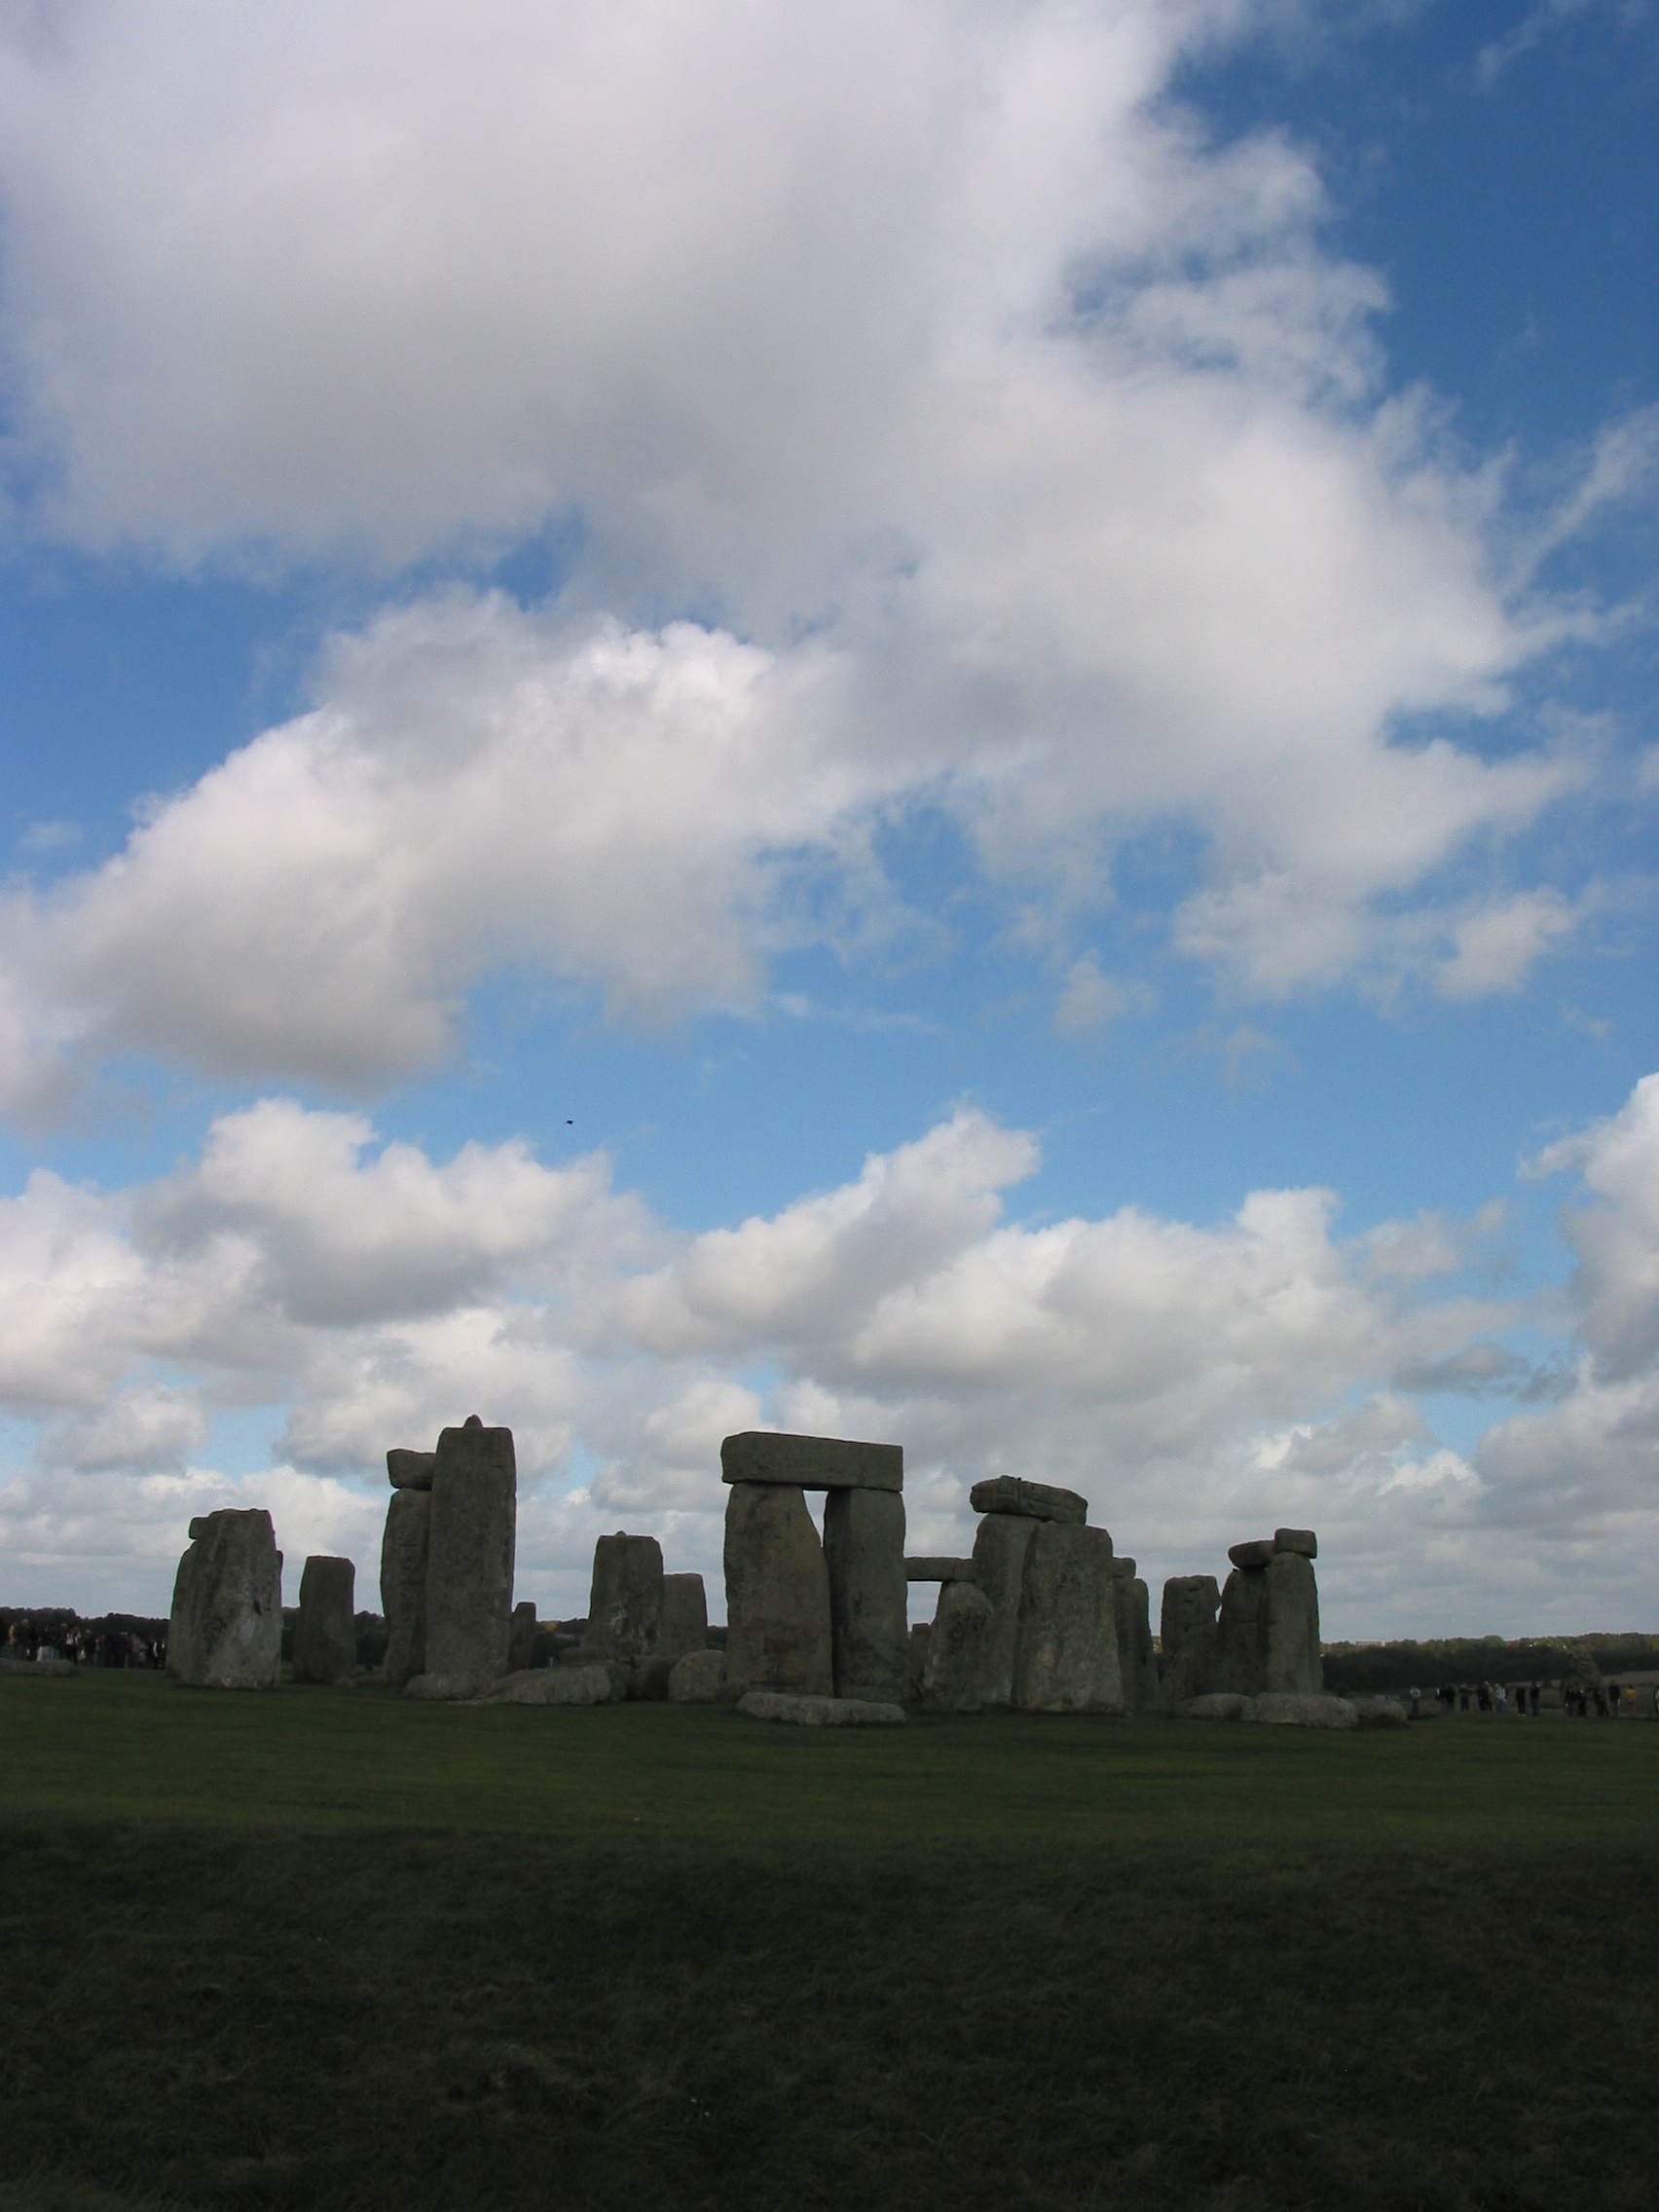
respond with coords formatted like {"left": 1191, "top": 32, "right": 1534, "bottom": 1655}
{"left": 0, "top": 0, "right": 1659, "bottom": 1637}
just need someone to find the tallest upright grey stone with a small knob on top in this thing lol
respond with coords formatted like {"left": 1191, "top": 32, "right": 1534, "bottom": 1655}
{"left": 426, "top": 1414, "right": 518, "bottom": 1690}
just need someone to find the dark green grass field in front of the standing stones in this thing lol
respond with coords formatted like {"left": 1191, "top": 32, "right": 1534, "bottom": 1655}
{"left": 0, "top": 1675, "right": 1659, "bottom": 2212}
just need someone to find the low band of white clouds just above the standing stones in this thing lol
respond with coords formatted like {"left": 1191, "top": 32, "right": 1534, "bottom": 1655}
{"left": 16, "top": 1077, "right": 1659, "bottom": 1633}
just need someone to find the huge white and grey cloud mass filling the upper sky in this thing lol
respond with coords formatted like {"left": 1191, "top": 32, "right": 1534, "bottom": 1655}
{"left": 0, "top": 0, "right": 1628, "bottom": 1088}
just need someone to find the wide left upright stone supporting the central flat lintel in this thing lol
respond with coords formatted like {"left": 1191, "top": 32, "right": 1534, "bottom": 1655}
{"left": 723, "top": 1482, "right": 834, "bottom": 1699}
